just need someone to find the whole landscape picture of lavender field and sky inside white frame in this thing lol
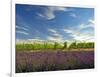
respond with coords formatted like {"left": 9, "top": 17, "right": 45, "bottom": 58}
{"left": 15, "top": 4, "right": 95, "bottom": 73}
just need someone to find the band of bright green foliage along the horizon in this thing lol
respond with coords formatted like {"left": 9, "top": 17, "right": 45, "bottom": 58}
{"left": 16, "top": 41, "right": 94, "bottom": 50}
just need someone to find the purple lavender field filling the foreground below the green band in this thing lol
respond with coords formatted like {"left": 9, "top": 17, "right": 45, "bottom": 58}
{"left": 16, "top": 51, "right": 94, "bottom": 73}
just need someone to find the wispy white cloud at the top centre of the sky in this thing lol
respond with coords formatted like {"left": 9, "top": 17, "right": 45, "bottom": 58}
{"left": 38, "top": 6, "right": 72, "bottom": 20}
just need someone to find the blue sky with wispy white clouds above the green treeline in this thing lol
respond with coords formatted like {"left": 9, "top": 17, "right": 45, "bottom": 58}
{"left": 16, "top": 4, "right": 95, "bottom": 42}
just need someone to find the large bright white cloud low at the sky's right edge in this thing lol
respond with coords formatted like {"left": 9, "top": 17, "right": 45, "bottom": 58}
{"left": 63, "top": 18, "right": 94, "bottom": 41}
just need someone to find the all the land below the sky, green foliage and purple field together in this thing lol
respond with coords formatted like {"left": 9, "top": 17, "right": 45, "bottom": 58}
{"left": 16, "top": 42, "right": 94, "bottom": 73}
